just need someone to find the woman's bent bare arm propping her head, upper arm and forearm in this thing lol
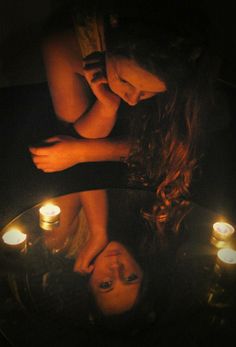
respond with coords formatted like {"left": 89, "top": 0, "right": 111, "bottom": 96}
{"left": 43, "top": 32, "right": 119, "bottom": 138}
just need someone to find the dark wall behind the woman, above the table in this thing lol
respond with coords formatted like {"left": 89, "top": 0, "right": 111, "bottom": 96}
{"left": 0, "top": 0, "right": 236, "bottom": 86}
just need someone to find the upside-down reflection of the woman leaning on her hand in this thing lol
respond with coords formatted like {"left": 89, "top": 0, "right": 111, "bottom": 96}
{"left": 40, "top": 190, "right": 166, "bottom": 329}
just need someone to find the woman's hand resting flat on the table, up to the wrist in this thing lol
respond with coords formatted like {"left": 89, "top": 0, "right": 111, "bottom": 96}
{"left": 29, "top": 136, "right": 83, "bottom": 172}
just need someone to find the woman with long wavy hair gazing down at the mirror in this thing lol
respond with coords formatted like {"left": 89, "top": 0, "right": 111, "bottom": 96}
{"left": 30, "top": 4, "right": 215, "bottom": 237}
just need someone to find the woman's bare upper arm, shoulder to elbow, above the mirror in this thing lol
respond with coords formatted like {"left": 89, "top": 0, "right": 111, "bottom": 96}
{"left": 43, "top": 32, "right": 89, "bottom": 123}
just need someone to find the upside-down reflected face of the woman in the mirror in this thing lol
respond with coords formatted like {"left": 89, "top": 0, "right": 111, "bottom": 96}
{"left": 90, "top": 241, "right": 143, "bottom": 315}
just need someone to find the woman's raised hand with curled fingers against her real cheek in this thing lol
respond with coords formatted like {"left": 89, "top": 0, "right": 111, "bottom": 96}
{"left": 84, "top": 52, "right": 120, "bottom": 110}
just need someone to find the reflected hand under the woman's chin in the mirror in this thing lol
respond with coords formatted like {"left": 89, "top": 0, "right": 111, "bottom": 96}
{"left": 74, "top": 233, "right": 108, "bottom": 275}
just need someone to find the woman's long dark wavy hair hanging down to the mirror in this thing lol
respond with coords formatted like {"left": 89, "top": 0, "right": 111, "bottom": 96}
{"left": 105, "top": 6, "right": 215, "bottom": 234}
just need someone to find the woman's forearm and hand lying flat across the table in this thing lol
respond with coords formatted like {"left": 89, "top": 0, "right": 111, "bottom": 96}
{"left": 29, "top": 136, "right": 130, "bottom": 172}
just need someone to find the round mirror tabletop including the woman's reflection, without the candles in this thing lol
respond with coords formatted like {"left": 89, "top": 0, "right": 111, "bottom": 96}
{"left": 0, "top": 189, "right": 236, "bottom": 347}
